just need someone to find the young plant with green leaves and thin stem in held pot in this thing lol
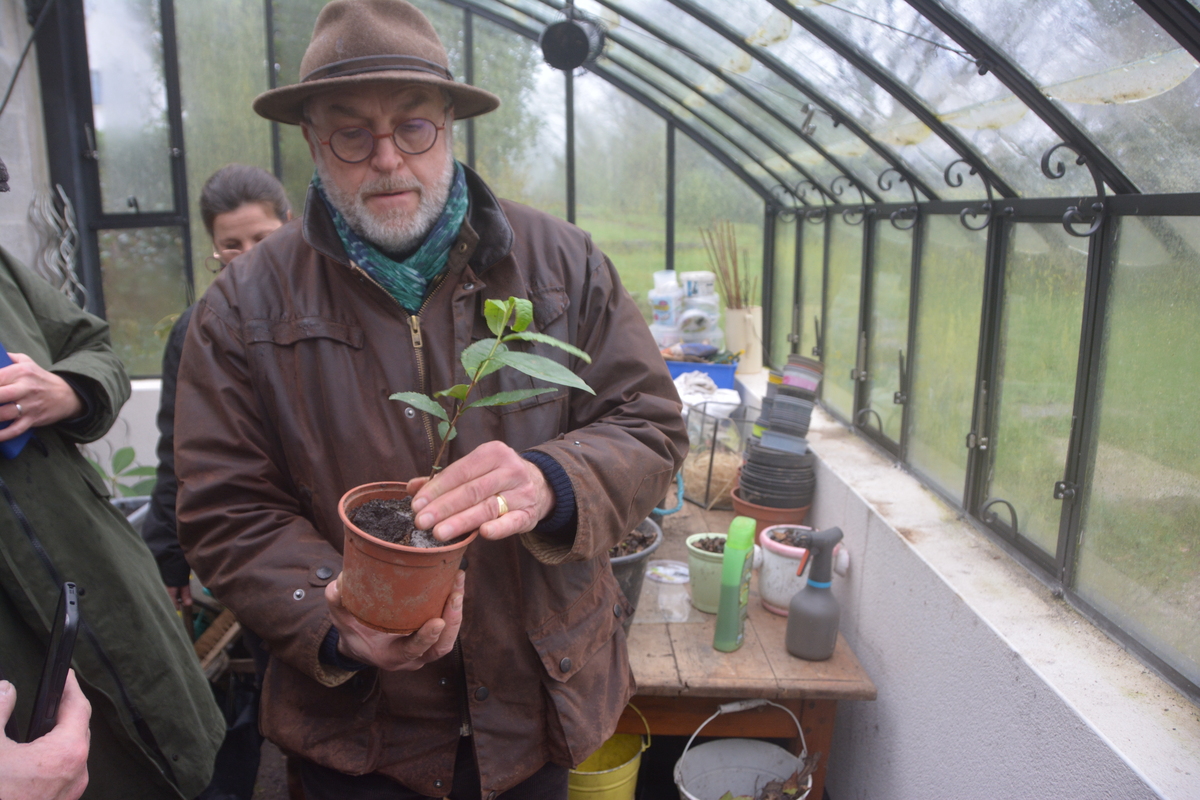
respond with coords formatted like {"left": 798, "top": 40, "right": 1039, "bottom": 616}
{"left": 390, "top": 297, "right": 595, "bottom": 479}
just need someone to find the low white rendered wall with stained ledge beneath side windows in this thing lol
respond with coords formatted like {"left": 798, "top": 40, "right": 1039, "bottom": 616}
{"left": 809, "top": 411, "right": 1200, "bottom": 800}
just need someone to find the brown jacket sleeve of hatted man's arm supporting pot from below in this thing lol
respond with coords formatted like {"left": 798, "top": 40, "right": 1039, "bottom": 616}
{"left": 175, "top": 292, "right": 353, "bottom": 686}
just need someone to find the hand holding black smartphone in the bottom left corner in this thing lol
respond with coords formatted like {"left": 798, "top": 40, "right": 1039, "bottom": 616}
{"left": 0, "top": 669, "right": 91, "bottom": 800}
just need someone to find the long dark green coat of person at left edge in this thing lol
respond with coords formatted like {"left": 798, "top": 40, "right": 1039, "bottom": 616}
{"left": 0, "top": 249, "right": 224, "bottom": 800}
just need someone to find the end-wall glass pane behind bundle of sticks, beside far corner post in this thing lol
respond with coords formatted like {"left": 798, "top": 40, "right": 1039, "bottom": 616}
{"left": 674, "top": 133, "right": 764, "bottom": 311}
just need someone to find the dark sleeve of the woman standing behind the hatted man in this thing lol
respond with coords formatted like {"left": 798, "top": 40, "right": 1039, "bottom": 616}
{"left": 142, "top": 308, "right": 192, "bottom": 587}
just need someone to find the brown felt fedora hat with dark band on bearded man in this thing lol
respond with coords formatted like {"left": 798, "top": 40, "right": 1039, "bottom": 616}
{"left": 254, "top": 0, "right": 500, "bottom": 125}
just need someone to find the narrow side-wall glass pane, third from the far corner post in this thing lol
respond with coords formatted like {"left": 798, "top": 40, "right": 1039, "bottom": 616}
{"left": 821, "top": 215, "right": 863, "bottom": 420}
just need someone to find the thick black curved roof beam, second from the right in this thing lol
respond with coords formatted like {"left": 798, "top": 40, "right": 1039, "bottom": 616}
{"left": 905, "top": 0, "right": 1138, "bottom": 194}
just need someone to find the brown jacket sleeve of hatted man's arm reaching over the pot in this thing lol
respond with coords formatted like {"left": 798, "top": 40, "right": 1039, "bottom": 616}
{"left": 524, "top": 242, "right": 688, "bottom": 564}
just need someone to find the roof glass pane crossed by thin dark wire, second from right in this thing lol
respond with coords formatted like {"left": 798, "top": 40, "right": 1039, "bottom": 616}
{"left": 802, "top": 0, "right": 1091, "bottom": 197}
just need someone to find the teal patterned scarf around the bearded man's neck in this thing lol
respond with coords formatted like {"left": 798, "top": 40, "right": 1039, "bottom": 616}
{"left": 312, "top": 161, "right": 468, "bottom": 314}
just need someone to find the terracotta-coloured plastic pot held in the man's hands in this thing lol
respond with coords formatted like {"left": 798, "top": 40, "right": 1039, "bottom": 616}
{"left": 337, "top": 482, "right": 479, "bottom": 633}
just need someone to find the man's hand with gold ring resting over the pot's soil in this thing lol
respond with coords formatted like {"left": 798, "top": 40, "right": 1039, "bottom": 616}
{"left": 408, "top": 441, "right": 554, "bottom": 542}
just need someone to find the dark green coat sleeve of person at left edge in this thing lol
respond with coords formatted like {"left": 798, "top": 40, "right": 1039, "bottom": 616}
{"left": 0, "top": 249, "right": 130, "bottom": 443}
